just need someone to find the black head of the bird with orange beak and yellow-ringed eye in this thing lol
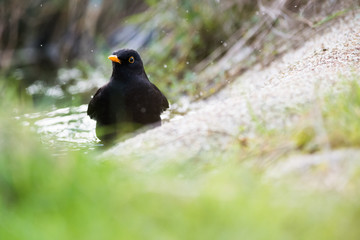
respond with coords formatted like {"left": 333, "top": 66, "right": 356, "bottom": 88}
{"left": 108, "top": 49, "right": 144, "bottom": 76}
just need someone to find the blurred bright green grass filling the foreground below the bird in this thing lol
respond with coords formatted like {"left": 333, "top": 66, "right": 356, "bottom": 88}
{"left": 0, "top": 78, "right": 360, "bottom": 240}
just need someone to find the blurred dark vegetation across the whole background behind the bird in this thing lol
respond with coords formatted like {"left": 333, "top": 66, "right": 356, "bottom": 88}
{"left": 0, "top": 0, "right": 356, "bottom": 108}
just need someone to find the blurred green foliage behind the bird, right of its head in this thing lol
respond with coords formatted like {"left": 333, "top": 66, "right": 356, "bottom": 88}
{"left": 136, "top": 0, "right": 258, "bottom": 100}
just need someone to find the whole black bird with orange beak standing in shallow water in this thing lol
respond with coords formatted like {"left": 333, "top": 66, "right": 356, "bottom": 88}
{"left": 87, "top": 49, "right": 169, "bottom": 141}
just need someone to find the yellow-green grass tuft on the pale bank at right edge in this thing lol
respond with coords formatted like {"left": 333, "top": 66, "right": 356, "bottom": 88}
{"left": 292, "top": 75, "right": 360, "bottom": 150}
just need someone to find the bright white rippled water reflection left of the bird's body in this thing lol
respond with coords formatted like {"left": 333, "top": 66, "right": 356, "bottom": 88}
{"left": 20, "top": 104, "right": 102, "bottom": 153}
